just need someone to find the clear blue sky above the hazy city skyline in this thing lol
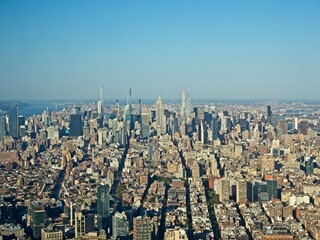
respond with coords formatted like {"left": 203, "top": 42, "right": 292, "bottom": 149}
{"left": 0, "top": 0, "right": 320, "bottom": 99}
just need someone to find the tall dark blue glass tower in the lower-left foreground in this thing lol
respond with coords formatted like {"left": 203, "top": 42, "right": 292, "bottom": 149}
{"left": 97, "top": 184, "right": 110, "bottom": 230}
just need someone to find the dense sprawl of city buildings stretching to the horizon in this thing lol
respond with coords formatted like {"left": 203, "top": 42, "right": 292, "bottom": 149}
{"left": 0, "top": 89, "right": 320, "bottom": 240}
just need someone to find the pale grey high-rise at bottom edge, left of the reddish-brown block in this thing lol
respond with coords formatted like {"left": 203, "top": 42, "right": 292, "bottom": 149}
{"left": 112, "top": 212, "right": 129, "bottom": 239}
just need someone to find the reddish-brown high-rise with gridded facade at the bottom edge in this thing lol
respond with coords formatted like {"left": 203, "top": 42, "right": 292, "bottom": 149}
{"left": 133, "top": 216, "right": 152, "bottom": 240}
